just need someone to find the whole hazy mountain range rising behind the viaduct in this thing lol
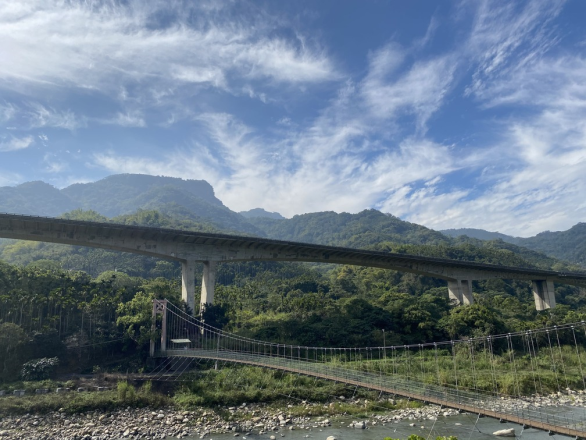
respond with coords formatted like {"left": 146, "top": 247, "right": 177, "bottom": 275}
{"left": 0, "top": 174, "right": 586, "bottom": 267}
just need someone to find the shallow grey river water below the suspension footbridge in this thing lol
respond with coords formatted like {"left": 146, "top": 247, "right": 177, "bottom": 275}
{"left": 190, "top": 407, "right": 584, "bottom": 440}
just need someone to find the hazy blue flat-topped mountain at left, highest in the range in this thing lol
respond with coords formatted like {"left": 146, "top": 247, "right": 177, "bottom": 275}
{"left": 0, "top": 174, "right": 260, "bottom": 234}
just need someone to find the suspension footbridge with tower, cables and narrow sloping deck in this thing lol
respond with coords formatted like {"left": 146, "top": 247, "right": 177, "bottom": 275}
{"left": 150, "top": 300, "right": 586, "bottom": 438}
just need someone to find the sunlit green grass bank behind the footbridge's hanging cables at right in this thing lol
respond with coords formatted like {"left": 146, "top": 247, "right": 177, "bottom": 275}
{"left": 332, "top": 345, "right": 586, "bottom": 396}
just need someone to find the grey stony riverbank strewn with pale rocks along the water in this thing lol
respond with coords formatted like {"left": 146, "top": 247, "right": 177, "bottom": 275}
{"left": 0, "top": 393, "right": 586, "bottom": 440}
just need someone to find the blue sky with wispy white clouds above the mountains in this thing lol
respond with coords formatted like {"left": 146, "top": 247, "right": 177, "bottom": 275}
{"left": 0, "top": 0, "right": 586, "bottom": 236}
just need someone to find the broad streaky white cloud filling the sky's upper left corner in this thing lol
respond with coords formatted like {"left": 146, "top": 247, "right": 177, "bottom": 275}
{"left": 0, "top": 0, "right": 337, "bottom": 101}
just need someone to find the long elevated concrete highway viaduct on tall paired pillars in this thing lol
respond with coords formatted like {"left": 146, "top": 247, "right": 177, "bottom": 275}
{"left": 0, "top": 214, "right": 586, "bottom": 310}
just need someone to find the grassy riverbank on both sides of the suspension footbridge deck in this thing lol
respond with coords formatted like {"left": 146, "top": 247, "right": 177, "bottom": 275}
{"left": 0, "top": 347, "right": 586, "bottom": 416}
